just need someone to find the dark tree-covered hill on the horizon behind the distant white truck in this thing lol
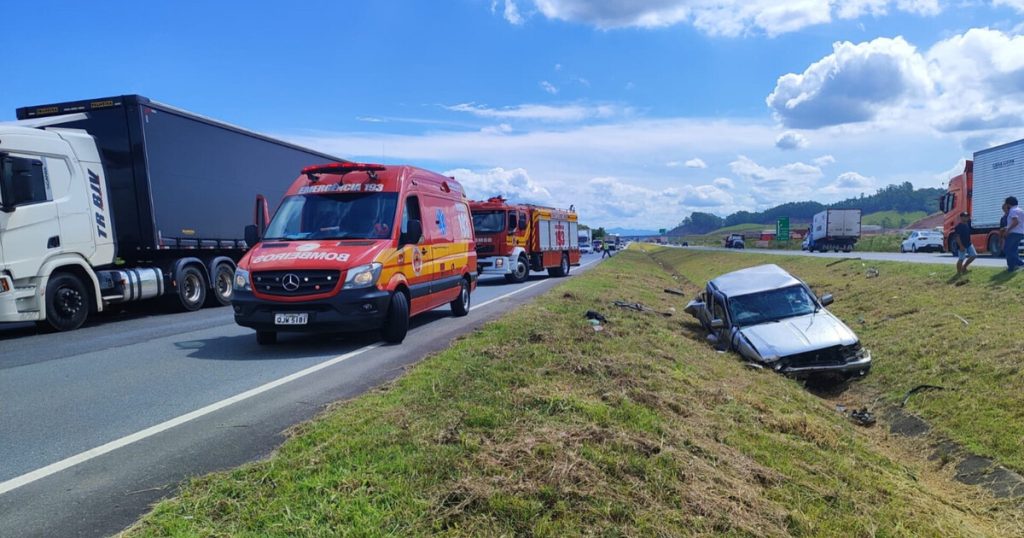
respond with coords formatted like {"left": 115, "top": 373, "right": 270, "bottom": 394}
{"left": 668, "top": 181, "right": 945, "bottom": 236}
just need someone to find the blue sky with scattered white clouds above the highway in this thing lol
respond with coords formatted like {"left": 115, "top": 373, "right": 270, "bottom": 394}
{"left": 0, "top": 0, "right": 1024, "bottom": 229}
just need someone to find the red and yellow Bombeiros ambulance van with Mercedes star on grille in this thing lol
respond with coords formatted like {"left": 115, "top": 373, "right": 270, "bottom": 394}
{"left": 231, "top": 162, "right": 476, "bottom": 344}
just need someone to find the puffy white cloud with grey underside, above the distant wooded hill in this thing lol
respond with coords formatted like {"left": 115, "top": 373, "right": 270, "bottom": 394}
{"left": 767, "top": 37, "right": 932, "bottom": 128}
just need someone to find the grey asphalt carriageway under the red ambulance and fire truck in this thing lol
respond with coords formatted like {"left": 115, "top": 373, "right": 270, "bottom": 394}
{"left": 0, "top": 254, "right": 599, "bottom": 537}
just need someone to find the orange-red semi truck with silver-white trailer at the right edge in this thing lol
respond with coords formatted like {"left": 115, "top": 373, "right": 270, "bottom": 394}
{"left": 939, "top": 139, "right": 1024, "bottom": 256}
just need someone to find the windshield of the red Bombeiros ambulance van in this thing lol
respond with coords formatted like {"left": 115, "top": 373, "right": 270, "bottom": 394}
{"left": 264, "top": 193, "right": 398, "bottom": 241}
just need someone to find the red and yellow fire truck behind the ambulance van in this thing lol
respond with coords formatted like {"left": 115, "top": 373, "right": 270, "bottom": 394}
{"left": 469, "top": 197, "right": 580, "bottom": 282}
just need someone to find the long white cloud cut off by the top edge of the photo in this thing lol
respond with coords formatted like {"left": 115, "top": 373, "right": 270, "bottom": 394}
{"left": 516, "top": 0, "right": 937, "bottom": 37}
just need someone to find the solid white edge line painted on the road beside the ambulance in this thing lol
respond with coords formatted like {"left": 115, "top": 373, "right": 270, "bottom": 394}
{"left": 0, "top": 256, "right": 599, "bottom": 495}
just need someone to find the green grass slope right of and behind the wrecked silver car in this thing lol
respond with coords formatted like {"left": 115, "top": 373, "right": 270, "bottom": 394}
{"left": 654, "top": 244, "right": 1024, "bottom": 472}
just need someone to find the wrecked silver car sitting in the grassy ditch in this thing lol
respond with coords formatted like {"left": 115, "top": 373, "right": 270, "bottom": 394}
{"left": 686, "top": 264, "right": 871, "bottom": 378}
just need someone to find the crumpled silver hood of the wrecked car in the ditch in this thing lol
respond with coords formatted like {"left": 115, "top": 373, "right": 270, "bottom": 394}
{"left": 739, "top": 308, "right": 857, "bottom": 360}
